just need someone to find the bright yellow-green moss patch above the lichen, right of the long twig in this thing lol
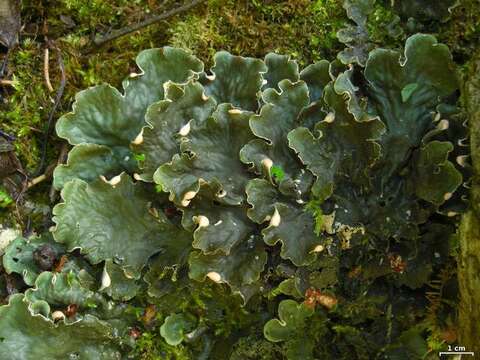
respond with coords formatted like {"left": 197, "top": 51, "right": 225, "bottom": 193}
{"left": 169, "top": 0, "right": 345, "bottom": 64}
